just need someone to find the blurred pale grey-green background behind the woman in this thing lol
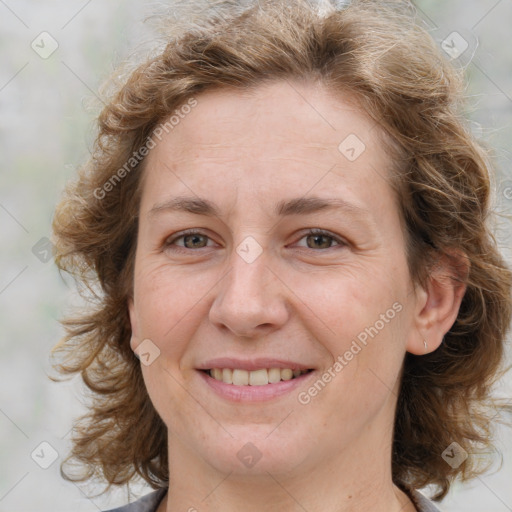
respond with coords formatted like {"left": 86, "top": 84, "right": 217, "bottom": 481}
{"left": 0, "top": 0, "right": 512, "bottom": 512}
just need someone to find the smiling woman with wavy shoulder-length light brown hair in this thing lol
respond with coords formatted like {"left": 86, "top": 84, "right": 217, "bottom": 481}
{"left": 54, "top": 0, "right": 512, "bottom": 512}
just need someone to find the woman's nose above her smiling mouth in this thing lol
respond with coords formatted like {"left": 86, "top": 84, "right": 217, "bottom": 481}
{"left": 209, "top": 252, "right": 289, "bottom": 338}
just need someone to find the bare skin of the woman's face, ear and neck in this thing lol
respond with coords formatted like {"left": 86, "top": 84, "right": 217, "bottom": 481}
{"left": 129, "top": 81, "right": 464, "bottom": 512}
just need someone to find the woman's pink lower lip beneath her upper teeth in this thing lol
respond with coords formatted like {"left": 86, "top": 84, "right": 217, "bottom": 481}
{"left": 198, "top": 370, "right": 315, "bottom": 402}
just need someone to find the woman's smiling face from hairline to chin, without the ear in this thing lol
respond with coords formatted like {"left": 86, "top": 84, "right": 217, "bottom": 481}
{"left": 129, "top": 82, "right": 421, "bottom": 480}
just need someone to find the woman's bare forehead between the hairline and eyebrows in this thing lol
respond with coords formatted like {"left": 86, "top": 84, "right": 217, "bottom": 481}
{"left": 139, "top": 81, "right": 396, "bottom": 215}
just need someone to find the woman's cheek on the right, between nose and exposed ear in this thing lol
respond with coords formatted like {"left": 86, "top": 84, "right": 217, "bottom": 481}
{"left": 297, "top": 260, "right": 409, "bottom": 404}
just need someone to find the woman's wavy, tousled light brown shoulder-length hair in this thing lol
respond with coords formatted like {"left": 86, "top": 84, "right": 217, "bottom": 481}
{"left": 52, "top": 0, "right": 512, "bottom": 499}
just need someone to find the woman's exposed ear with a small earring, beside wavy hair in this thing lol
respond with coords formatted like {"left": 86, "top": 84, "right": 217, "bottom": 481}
{"left": 406, "top": 250, "right": 470, "bottom": 355}
